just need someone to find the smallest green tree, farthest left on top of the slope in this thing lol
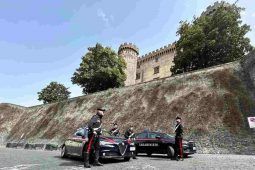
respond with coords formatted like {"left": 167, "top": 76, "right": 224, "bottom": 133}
{"left": 38, "top": 82, "right": 70, "bottom": 104}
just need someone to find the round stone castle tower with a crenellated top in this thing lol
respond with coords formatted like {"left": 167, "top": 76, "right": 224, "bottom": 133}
{"left": 118, "top": 43, "right": 139, "bottom": 86}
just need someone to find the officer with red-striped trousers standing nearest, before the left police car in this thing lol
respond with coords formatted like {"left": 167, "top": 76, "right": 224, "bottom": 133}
{"left": 84, "top": 108, "right": 105, "bottom": 168}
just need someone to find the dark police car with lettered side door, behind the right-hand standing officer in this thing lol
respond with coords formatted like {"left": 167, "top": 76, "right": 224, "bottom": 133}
{"left": 135, "top": 131, "right": 196, "bottom": 158}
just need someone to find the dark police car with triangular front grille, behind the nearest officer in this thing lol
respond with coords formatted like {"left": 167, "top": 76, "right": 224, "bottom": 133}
{"left": 61, "top": 128, "right": 135, "bottom": 161}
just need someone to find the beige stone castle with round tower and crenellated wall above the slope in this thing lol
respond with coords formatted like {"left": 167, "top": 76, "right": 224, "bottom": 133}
{"left": 118, "top": 43, "right": 176, "bottom": 86}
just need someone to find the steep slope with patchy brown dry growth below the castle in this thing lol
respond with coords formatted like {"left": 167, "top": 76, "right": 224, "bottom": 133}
{"left": 0, "top": 63, "right": 255, "bottom": 153}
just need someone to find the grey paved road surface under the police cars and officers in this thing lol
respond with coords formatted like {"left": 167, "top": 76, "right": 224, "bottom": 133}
{"left": 0, "top": 148, "right": 255, "bottom": 170}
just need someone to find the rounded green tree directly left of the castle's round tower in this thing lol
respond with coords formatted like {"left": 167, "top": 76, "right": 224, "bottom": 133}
{"left": 71, "top": 43, "right": 126, "bottom": 94}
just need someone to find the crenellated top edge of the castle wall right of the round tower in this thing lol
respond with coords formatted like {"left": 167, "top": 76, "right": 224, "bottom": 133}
{"left": 137, "top": 43, "right": 175, "bottom": 62}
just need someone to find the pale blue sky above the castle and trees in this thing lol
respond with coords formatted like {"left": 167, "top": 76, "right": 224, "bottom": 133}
{"left": 0, "top": 0, "right": 255, "bottom": 106}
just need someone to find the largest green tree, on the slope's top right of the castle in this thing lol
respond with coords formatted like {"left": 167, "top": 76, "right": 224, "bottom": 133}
{"left": 171, "top": 2, "right": 252, "bottom": 74}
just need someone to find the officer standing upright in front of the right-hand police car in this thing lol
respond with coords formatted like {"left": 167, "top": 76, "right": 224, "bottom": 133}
{"left": 174, "top": 116, "right": 183, "bottom": 161}
